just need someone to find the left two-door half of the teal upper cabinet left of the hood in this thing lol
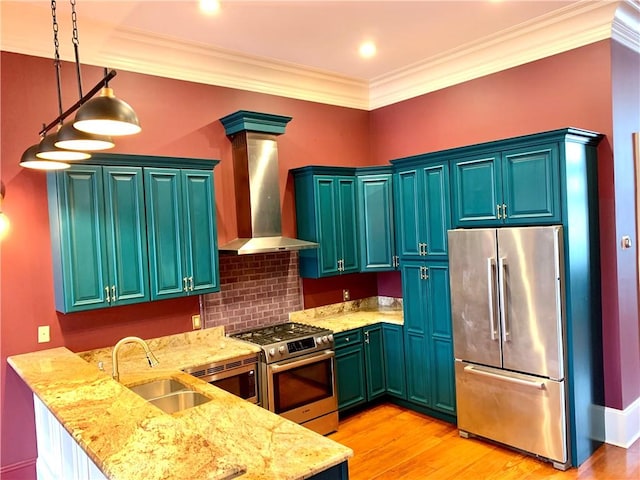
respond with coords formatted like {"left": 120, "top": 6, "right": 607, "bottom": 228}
{"left": 47, "top": 165, "right": 150, "bottom": 313}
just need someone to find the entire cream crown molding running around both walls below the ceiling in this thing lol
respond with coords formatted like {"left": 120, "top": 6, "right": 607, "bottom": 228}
{"left": 0, "top": 0, "right": 640, "bottom": 110}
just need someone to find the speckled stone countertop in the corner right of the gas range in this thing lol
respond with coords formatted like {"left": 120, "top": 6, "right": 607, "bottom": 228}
{"left": 289, "top": 297, "right": 404, "bottom": 333}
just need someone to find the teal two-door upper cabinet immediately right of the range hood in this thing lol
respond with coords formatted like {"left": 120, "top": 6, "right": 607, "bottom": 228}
{"left": 291, "top": 166, "right": 360, "bottom": 278}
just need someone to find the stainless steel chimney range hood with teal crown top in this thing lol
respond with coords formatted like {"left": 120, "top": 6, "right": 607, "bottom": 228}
{"left": 218, "top": 110, "right": 318, "bottom": 255}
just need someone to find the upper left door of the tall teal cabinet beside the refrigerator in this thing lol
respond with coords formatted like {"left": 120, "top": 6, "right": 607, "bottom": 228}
{"left": 393, "top": 170, "right": 422, "bottom": 259}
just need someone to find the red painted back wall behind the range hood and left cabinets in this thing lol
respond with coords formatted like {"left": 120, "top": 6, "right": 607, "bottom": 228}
{"left": 0, "top": 52, "right": 375, "bottom": 480}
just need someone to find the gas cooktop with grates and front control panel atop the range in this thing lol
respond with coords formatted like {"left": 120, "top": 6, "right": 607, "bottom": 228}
{"left": 229, "top": 322, "right": 333, "bottom": 363}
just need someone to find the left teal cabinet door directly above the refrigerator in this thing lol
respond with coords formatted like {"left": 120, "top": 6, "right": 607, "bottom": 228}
{"left": 452, "top": 154, "right": 502, "bottom": 227}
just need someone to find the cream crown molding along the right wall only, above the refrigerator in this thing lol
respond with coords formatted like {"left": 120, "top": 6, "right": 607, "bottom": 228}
{"left": 369, "top": 0, "right": 630, "bottom": 110}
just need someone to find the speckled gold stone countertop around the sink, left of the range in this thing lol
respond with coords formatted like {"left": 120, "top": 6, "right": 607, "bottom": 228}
{"left": 8, "top": 328, "right": 353, "bottom": 480}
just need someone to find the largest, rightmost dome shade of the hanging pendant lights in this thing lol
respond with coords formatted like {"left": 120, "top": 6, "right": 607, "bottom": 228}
{"left": 73, "top": 87, "right": 142, "bottom": 137}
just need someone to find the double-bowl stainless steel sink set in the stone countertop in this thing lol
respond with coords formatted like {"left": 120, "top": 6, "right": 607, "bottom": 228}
{"left": 128, "top": 378, "right": 211, "bottom": 413}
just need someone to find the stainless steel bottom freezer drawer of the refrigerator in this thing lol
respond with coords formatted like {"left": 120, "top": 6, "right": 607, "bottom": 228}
{"left": 456, "top": 360, "right": 568, "bottom": 464}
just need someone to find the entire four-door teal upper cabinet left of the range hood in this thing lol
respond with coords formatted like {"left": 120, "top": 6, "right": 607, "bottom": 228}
{"left": 47, "top": 154, "right": 219, "bottom": 313}
